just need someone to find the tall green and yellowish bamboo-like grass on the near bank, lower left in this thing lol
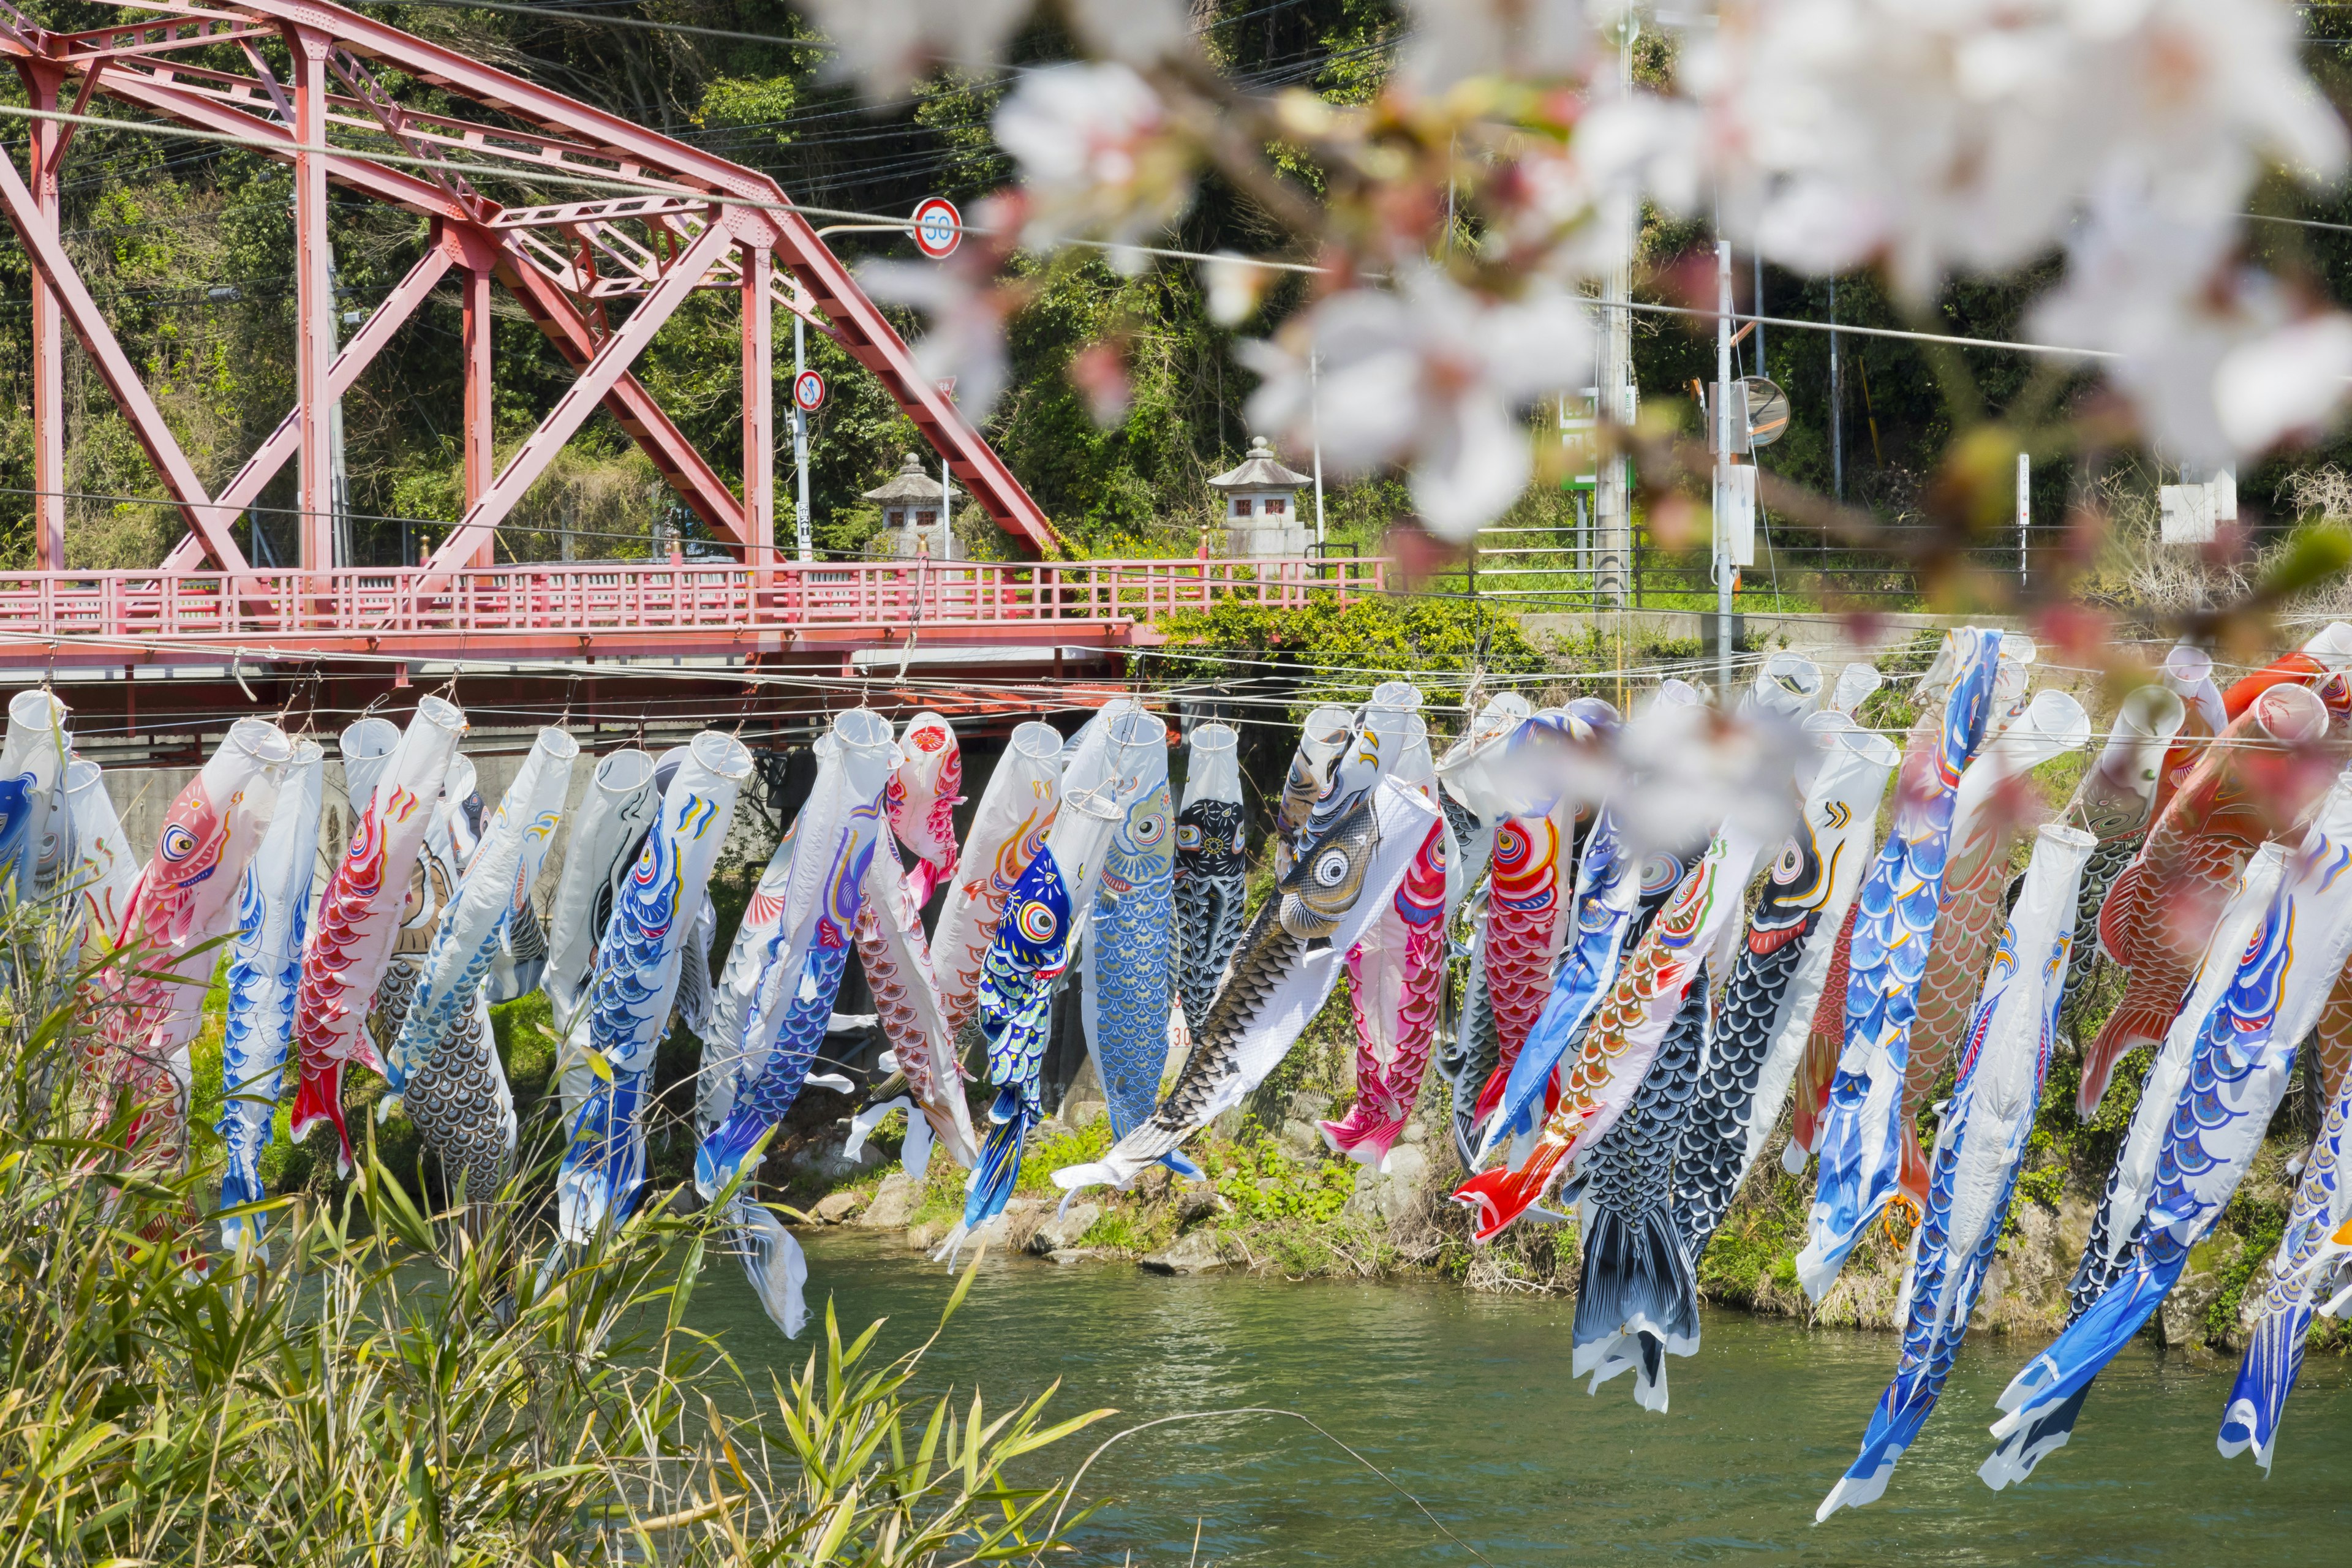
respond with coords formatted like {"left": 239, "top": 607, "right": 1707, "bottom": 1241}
{"left": 0, "top": 903, "right": 1103, "bottom": 1568}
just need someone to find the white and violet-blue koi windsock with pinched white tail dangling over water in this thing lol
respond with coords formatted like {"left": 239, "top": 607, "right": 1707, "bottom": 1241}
{"left": 691, "top": 707, "right": 903, "bottom": 1338}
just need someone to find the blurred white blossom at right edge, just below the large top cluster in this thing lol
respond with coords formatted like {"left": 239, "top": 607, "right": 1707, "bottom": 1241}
{"left": 2032, "top": 193, "right": 2352, "bottom": 466}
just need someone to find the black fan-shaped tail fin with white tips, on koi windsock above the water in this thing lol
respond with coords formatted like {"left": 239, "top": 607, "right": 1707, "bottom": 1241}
{"left": 1569, "top": 1208, "right": 1698, "bottom": 1413}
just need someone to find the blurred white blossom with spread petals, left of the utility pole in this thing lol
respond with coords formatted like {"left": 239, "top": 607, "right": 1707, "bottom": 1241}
{"left": 1235, "top": 268, "right": 1593, "bottom": 541}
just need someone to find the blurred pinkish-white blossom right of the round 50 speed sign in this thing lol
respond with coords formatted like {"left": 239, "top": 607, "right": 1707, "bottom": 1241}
{"left": 995, "top": 64, "right": 1193, "bottom": 275}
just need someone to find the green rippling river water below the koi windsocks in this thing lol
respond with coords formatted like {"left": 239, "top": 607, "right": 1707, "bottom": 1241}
{"left": 696, "top": 1232, "right": 2352, "bottom": 1568}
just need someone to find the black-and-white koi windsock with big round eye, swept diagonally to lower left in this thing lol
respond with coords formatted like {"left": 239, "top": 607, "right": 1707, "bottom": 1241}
{"left": 1054, "top": 747, "right": 1437, "bottom": 1192}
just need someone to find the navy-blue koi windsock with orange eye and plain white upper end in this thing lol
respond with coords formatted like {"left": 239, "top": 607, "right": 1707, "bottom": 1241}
{"left": 932, "top": 707, "right": 1167, "bottom": 1260}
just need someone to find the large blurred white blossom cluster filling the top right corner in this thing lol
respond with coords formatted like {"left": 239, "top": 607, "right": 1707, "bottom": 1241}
{"left": 1677, "top": 0, "right": 2345, "bottom": 298}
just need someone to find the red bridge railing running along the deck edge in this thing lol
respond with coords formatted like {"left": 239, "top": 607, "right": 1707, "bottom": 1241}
{"left": 0, "top": 557, "right": 1388, "bottom": 663}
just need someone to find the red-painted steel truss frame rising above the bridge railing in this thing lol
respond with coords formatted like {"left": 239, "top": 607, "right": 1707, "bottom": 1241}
{"left": 0, "top": 0, "right": 1058, "bottom": 592}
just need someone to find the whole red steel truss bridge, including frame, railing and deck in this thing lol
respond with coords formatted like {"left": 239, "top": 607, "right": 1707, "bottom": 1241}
{"left": 0, "top": 0, "right": 1381, "bottom": 733}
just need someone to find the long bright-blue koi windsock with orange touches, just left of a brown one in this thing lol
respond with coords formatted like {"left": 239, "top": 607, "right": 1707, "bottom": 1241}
{"left": 1797, "top": 628, "right": 1999, "bottom": 1302}
